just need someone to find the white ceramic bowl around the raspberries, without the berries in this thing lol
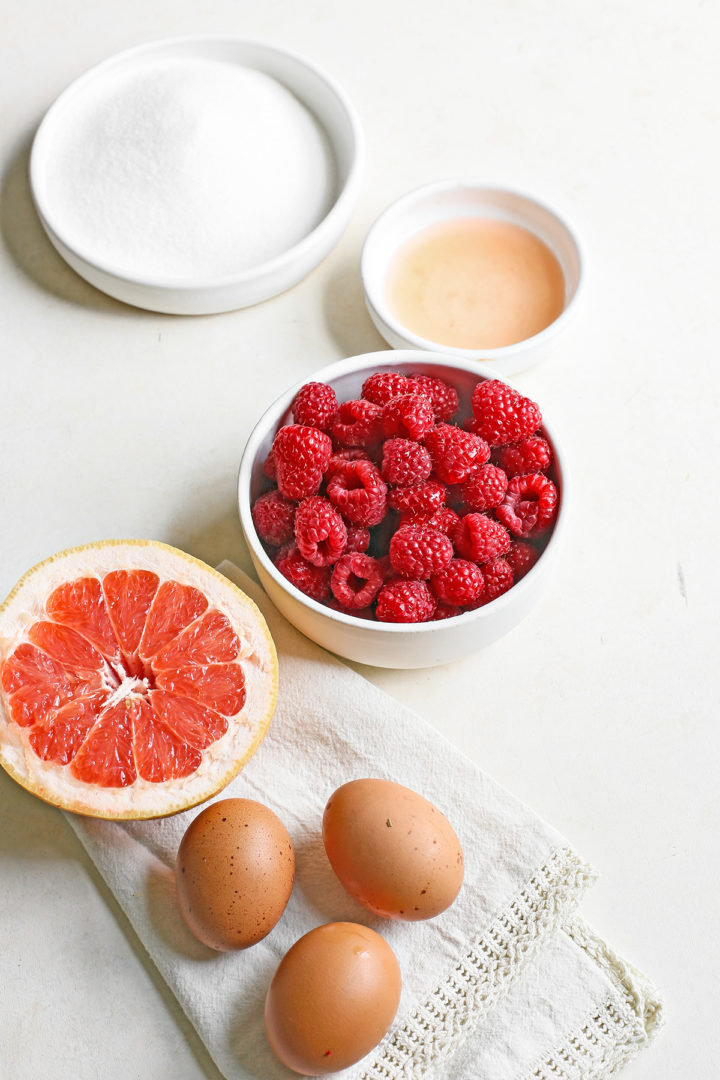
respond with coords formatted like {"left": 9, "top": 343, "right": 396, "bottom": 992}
{"left": 237, "top": 350, "right": 569, "bottom": 667}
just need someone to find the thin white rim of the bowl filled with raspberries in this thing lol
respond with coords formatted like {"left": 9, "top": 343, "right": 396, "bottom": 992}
{"left": 237, "top": 349, "right": 570, "bottom": 634}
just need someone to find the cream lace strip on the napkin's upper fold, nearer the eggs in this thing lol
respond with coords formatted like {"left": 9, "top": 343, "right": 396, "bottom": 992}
{"left": 362, "top": 849, "right": 595, "bottom": 1080}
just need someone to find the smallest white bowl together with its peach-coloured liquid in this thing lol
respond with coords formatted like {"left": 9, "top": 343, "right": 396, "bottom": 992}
{"left": 362, "top": 179, "right": 582, "bottom": 375}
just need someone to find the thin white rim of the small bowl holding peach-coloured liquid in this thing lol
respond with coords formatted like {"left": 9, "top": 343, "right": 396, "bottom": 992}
{"left": 361, "top": 178, "right": 584, "bottom": 360}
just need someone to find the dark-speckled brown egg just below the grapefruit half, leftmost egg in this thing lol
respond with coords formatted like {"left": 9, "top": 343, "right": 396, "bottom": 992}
{"left": 177, "top": 799, "right": 295, "bottom": 950}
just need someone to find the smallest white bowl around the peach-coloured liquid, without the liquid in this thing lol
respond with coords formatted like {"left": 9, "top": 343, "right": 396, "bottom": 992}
{"left": 361, "top": 180, "right": 582, "bottom": 375}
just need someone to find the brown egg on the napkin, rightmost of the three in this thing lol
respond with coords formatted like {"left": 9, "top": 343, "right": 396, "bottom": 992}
{"left": 323, "top": 780, "right": 464, "bottom": 921}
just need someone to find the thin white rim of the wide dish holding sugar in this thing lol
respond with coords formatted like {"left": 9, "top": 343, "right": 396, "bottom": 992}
{"left": 29, "top": 33, "right": 365, "bottom": 293}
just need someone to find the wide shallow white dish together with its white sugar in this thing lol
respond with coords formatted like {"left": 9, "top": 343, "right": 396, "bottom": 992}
{"left": 30, "top": 37, "right": 363, "bottom": 314}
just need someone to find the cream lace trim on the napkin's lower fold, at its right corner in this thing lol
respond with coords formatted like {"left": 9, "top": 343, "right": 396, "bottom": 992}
{"left": 524, "top": 917, "right": 664, "bottom": 1080}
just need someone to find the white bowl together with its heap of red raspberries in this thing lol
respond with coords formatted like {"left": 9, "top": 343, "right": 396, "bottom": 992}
{"left": 239, "top": 350, "right": 568, "bottom": 667}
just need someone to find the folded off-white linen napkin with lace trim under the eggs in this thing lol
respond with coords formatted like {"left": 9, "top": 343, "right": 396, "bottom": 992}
{"left": 67, "top": 563, "right": 662, "bottom": 1080}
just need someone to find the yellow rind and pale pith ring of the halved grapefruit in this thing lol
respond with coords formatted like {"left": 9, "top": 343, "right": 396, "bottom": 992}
{"left": 0, "top": 540, "right": 277, "bottom": 820}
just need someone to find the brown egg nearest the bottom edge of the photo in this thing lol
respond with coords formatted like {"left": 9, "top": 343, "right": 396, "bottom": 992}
{"left": 264, "top": 922, "right": 403, "bottom": 1077}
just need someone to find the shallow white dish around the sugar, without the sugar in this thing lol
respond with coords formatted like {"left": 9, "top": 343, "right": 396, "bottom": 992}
{"left": 30, "top": 37, "right": 364, "bottom": 315}
